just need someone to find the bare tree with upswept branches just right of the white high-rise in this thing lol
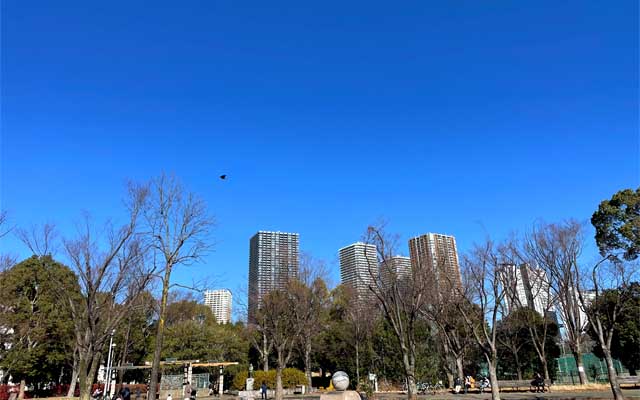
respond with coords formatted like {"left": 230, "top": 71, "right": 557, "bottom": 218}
{"left": 523, "top": 220, "right": 587, "bottom": 384}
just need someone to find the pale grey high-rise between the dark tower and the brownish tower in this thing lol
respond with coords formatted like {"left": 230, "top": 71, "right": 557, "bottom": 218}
{"left": 339, "top": 242, "right": 378, "bottom": 301}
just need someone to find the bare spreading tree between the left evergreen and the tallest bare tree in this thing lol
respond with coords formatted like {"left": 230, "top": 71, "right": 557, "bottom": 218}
{"left": 62, "top": 186, "right": 154, "bottom": 400}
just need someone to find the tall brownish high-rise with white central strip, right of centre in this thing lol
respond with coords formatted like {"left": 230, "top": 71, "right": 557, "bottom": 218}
{"left": 409, "top": 233, "right": 462, "bottom": 293}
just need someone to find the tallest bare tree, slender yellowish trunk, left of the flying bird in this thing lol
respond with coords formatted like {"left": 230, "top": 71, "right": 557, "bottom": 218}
{"left": 144, "top": 174, "right": 214, "bottom": 399}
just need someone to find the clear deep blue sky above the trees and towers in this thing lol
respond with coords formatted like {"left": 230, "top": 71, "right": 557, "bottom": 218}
{"left": 0, "top": 0, "right": 640, "bottom": 316}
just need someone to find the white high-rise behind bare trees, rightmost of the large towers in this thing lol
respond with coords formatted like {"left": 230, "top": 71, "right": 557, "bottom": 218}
{"left": 502, "top": 264, "right": 555, "bottom": 315}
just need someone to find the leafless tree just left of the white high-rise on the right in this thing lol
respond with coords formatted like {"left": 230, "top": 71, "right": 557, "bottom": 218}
{"left": 456, "top": 240, "right": 506, "bottom": 400}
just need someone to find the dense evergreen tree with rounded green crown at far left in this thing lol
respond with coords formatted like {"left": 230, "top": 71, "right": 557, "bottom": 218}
{"left": 0, "top": 256, "right": 80, "bottom": 382}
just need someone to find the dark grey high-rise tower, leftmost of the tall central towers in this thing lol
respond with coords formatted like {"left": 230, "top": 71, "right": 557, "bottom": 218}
{"left": 248, "top": 231, "right": 300, "bottom": 322}
